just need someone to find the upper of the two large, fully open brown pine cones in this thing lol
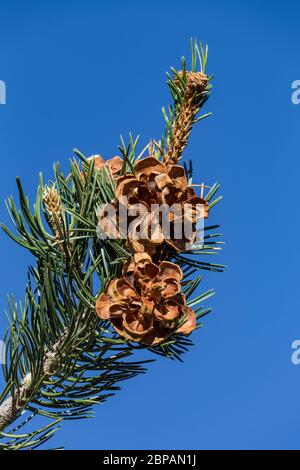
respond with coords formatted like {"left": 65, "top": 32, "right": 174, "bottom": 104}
{"left": 99, "top": 157, "right": 209, "bottom": 255}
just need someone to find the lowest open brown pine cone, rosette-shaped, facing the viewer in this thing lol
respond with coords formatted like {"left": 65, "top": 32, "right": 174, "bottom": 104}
{"left": 96, "top": 253, "right": 196, "bottom": 346}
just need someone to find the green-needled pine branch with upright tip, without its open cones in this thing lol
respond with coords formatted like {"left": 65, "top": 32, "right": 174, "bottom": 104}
{"left": 0, "top": 40, "right": 223, "bottom": 450}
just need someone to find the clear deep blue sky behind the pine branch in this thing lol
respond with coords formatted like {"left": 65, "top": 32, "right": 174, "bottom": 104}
{"left": 0, "top": 0, "right": 300, "bottom": 449}
